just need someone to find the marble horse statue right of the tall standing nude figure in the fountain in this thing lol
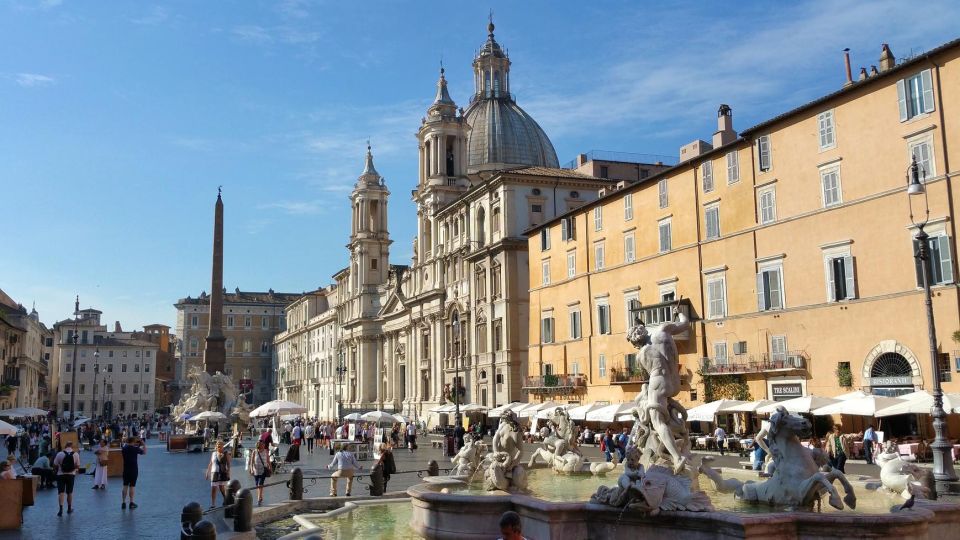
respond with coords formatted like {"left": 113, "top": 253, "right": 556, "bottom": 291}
{"left": 699, "top": 407, "right": 857, "bottom": 510}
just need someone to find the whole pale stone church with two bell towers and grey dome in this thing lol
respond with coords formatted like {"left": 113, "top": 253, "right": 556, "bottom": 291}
{"left": 275, "top": 23, "right": 615, "bottom": 418}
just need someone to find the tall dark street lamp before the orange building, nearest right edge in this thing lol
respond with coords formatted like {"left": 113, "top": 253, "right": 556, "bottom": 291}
{"left": 907, "top": 155, "right": 960, "bottom": 493}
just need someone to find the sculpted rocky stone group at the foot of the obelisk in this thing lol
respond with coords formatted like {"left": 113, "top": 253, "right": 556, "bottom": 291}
{"left": 173, "top": 367, "right": 253, "bottom": 430}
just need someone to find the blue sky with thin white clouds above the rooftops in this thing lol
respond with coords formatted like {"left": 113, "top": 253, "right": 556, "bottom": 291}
{"left": 0, "top": 0, "right": 960, "bottom": 327}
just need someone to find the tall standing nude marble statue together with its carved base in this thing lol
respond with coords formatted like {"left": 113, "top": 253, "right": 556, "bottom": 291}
{"left": 590, "top": 307, "right": 713, "bottom": 515}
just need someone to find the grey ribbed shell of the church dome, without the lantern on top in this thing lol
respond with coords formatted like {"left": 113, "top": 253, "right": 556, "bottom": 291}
{"left": 464, "top": 97, "right": 560, "bottom": 169}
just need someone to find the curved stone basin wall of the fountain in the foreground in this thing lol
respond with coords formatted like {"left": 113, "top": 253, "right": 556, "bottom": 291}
{"left": 407, "top": 468, "right": 960, "bottom": 540}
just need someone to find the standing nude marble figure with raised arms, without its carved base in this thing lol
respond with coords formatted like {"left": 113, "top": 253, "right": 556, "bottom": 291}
{"left": 627, "top": 307, "right": 691, "bottom": 474}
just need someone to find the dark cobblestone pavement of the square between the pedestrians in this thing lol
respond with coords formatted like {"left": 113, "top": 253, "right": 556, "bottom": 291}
{"left": 0, "top": 439, "right": 879, "bottom": 540}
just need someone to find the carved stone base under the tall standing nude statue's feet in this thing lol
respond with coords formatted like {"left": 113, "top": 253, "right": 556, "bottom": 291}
{"left": 590, "top": 446, "right": 713, "bottom": 516}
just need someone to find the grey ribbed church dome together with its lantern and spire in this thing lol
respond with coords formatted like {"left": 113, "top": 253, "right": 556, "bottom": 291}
{"left": 464, "top": 21, "right": 560, "bottom": 170}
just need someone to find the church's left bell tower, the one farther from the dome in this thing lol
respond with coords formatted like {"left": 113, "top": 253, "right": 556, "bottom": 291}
{"left": 347, "top": 143, "right": 391, "bottom": 315}
